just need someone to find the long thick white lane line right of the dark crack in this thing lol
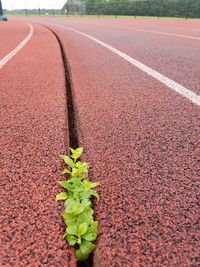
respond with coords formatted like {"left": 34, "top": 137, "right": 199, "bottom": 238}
{"left": 47, "top": 23, "right": 200, "bottom": 106}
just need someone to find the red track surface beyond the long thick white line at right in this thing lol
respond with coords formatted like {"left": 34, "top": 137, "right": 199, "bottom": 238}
{"left": 12, "top": 18, "right": 200, "bottom": 94}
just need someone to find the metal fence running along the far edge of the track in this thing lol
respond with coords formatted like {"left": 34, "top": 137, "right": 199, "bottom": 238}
{"left": 4, "top": 0, "right": 200, "bottom": 19}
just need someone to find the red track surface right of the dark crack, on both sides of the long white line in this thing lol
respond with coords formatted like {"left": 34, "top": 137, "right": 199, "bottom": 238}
{"left": 2, "top": 18, "right": 200, "bottom": 267}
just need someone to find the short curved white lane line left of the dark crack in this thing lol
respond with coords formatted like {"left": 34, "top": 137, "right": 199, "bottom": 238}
{"left": 0, "top": 24, "right": 33, "bottom": 69}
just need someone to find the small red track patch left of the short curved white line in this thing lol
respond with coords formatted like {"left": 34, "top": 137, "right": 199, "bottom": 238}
{"left": 0, "top": 21, "right": 30, "bottom": 59}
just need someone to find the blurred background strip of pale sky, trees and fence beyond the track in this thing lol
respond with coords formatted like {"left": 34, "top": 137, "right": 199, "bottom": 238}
{"left": 2, "top": 0, "right": 200, "bottom": 19}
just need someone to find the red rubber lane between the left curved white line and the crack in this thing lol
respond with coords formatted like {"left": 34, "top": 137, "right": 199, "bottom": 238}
{"left": 0, "top": 24, "right": 76, "bottom": 267}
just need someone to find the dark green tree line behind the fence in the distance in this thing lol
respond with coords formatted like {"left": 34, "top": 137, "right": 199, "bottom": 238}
{"left": 63, "top": 0, "right": 200, "bottom": 18}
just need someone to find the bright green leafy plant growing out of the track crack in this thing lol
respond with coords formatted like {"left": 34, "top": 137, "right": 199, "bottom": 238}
{"left": 56, "top": 148, "right": 100, "bottom": 261}
